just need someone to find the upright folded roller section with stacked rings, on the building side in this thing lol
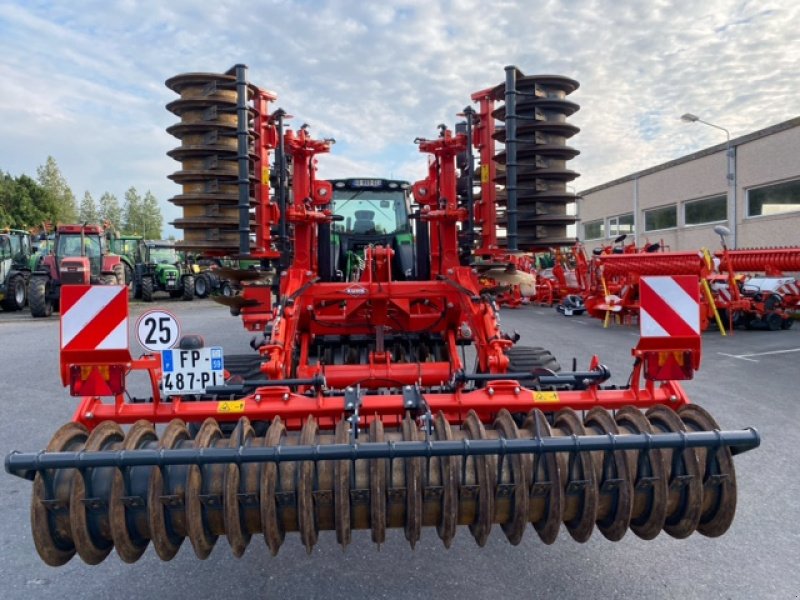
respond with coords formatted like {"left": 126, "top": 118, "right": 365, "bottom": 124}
{"left": 492, "top": 67, "right": 579, "bottom": 251}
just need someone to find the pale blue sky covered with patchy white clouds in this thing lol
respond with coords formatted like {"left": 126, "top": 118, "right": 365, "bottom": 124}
{"left": 0, "top": 0, "right": 800, "bottom": 237}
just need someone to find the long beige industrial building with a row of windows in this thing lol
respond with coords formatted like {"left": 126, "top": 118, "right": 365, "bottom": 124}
{"left": 578, "top": 114, "right": 800, "bottom": 250}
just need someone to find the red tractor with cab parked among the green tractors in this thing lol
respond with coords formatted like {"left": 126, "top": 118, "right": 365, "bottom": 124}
{"left": 28, "top": 225, "right": 125, "bottom": 317}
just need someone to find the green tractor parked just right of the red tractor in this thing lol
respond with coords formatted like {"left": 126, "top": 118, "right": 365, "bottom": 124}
{"left": 133, "top": 240, "right": 194, "bottom": 302}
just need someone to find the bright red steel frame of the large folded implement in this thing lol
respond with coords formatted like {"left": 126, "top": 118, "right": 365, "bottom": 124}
{"left": 62, "top": 84, "right": 700, "bottom": 429}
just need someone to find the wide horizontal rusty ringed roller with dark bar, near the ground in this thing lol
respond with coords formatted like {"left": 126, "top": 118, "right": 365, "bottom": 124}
{"left": 7, "top": 405, "right": 753, "bottom": 566}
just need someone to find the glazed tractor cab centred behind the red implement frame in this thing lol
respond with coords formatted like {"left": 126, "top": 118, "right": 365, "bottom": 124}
{"left": 331, "top": 179, "right": 414, "bottom": 281}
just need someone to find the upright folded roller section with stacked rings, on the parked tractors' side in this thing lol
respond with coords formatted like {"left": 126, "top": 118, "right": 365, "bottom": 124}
{"left": 166, "top": 67, "right": 255, "bottom": 254}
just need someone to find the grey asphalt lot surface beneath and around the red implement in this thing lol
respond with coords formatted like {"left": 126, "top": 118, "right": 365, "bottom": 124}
{"left": 0, "top": 300, "right": 800, "bottom": 600}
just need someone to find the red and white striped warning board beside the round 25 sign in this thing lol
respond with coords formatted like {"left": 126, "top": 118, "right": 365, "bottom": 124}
{"left": 61, "top": 285, "right": 128, "bottom": 351}
